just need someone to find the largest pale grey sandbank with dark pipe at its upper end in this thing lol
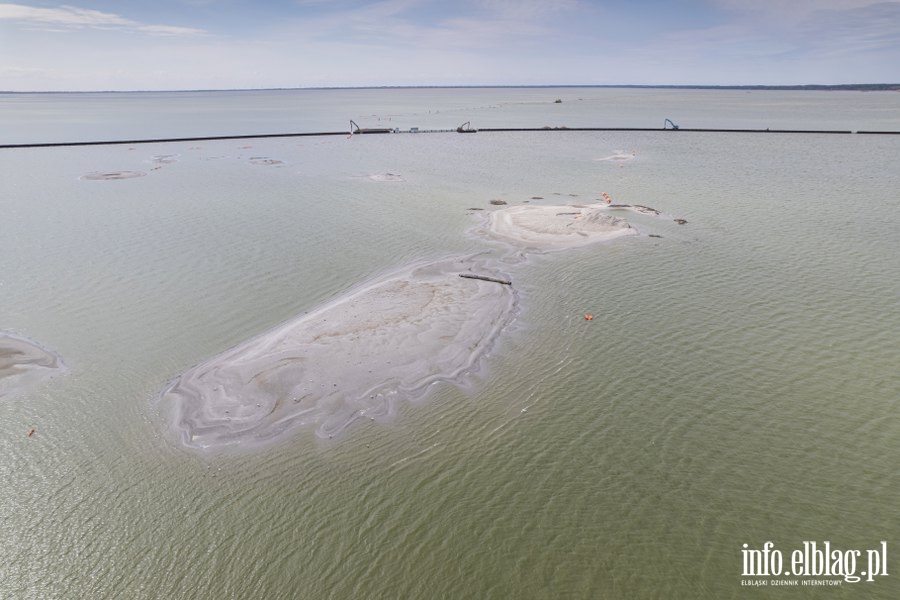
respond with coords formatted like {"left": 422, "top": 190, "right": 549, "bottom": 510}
{"left": 161, "top": 258, "right": 516, "bottom": 449}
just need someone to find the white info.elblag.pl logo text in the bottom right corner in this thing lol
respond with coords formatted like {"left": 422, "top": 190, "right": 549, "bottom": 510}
{"left": 741, "top": 541, "right": 888, "bottom": 585}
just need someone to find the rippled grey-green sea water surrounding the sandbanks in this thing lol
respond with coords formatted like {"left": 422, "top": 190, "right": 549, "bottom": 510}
{"left": 0, "top": 88, "right": 900, "bottom": 598}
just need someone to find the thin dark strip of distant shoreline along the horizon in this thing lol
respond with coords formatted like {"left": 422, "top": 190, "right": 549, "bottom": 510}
{"left": 0, "top": 83, "right": 900, "bottom": 94}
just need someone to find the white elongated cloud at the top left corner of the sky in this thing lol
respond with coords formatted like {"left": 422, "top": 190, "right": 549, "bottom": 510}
{"left": 0, "top": 4, "right": 206, "bottom": 36}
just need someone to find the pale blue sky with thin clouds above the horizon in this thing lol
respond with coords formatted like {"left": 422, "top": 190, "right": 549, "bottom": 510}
{"left": 0, "top": 0, "right": 900, "bottom": 91}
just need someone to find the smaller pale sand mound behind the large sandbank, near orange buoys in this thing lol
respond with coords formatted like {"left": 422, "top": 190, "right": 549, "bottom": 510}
{"left": 487, "top": 205, "right": 637, "bottom": 250}
